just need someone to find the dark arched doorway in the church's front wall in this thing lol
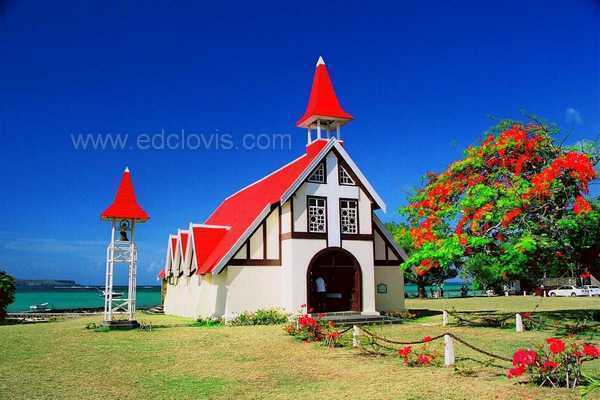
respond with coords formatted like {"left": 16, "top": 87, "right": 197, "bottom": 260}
{"left": 306, "top": 247, "right": 362, "bottom": 312}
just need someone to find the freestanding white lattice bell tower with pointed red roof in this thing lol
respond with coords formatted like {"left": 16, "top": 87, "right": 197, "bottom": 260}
{"left": 101, "top": 168, "right": 150, "bottom": 328}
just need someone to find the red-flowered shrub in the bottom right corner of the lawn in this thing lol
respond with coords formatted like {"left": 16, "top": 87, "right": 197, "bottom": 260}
{"left": 506, "top": 338, "right": 600, "bottom": 388}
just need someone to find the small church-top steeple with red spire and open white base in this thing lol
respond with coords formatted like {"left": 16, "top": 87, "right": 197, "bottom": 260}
{"left": 296, "top": 57, "right": 353, "bottom": 144}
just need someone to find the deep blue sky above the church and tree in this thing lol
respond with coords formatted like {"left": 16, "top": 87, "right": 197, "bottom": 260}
{"left": 0, "top": 0, "right": 600, "bottom": 283}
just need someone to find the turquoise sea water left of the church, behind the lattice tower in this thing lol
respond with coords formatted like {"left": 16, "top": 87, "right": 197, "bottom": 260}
{"left": 8, "top": 287, "right": 160, "bottom": 312}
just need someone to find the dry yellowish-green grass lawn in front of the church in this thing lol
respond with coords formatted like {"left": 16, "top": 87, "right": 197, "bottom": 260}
{"left": 0, "top": 297, "right": 600, "bottom": 400}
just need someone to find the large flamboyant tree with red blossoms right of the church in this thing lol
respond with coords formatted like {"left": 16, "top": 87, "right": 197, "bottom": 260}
{"left": 394, "top": 121, "right": 600, "bottom": 287}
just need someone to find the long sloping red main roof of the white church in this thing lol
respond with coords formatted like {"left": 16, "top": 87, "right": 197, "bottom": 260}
{"left": 193, "top": 139, "right": 328, "bottom": 274}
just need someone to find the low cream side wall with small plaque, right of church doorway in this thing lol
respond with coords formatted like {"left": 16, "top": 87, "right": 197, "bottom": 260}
{"left": 375, "top": 263, "right": 406, "bottom": 311}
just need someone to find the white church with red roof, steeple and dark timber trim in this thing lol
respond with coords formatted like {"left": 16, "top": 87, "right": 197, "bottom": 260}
{"left": 161, "top": 58, "right": 406, "bottom": 318}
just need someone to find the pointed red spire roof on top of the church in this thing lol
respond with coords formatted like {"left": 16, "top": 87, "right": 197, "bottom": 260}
{"left": 296, "top": 57, "right": 352, "bottom": 128}
